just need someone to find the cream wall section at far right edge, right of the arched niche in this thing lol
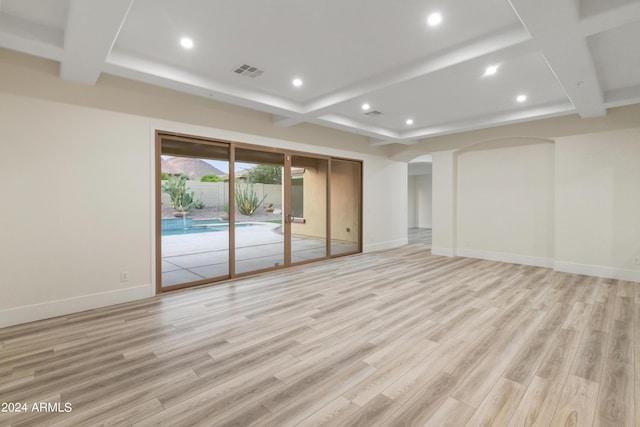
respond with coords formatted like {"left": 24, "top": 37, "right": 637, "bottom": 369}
{"left": 555, "top": 128, "right": 640, "bottom": 281}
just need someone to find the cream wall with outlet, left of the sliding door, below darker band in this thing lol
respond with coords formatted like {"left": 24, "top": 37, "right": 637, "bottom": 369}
{"left": 0, "top": 93, "right": 152, "bottom": 326}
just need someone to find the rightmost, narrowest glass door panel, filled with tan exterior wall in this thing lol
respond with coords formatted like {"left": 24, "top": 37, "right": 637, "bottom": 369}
{"left": 330, "top": 159, "right": 362, "bottom": 256}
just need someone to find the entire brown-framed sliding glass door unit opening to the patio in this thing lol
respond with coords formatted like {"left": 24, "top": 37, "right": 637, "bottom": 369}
{"left": 156, "top": 132, "right": 362, "bottom": 293}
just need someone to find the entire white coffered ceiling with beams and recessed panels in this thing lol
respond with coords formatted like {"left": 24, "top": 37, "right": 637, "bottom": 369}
{"left": 0, "top": 0, "right": 640, "bottom": 145}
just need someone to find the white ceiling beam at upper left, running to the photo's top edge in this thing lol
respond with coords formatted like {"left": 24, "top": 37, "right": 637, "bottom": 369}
{"left": 60, "top": 0, "right": 133, "bottom": 85}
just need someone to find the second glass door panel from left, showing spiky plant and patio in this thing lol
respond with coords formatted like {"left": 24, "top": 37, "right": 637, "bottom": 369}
{"left": 234, "top": 148, "right": 285, "bottom": 274}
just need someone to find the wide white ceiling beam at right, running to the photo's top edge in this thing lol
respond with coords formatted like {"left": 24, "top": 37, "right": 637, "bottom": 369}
{"left": 509, "top": 0, "right": 606, "bottom": 118}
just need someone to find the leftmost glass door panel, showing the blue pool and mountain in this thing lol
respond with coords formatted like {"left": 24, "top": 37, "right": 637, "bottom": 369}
{"left": 160, "top": 138, "right": 230, "bottom": 289}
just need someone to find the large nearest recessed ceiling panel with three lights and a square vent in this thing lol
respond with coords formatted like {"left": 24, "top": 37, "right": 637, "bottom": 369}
{"left": 115, "top": 0, "right": 519, "bottom": 103}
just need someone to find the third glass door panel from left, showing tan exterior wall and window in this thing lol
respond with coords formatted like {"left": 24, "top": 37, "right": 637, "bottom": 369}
{"left": 289, "top": 155, "right": 329, "bottom": 263}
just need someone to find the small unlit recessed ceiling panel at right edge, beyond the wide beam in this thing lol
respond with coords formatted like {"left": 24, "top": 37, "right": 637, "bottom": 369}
{"left": 588, "top": 22, "right": 640, "bottom": 91}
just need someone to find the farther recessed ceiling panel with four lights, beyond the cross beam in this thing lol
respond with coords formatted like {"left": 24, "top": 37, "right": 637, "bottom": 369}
{"left": 334, "top": 53, "right": 567, "bottom": 132}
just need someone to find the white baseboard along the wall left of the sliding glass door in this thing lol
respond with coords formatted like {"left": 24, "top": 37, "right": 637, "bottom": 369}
{"left": 0, "top": 285, "right": 153, "bottom": 328}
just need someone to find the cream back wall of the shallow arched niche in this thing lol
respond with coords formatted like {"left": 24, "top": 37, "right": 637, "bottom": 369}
{"left": 457, "top": 140, "right": 554, "bottom": 266}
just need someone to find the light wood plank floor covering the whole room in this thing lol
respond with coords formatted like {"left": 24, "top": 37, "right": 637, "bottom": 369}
{"left": 0, "top": 244, "right": 640, "bottom": 427}
